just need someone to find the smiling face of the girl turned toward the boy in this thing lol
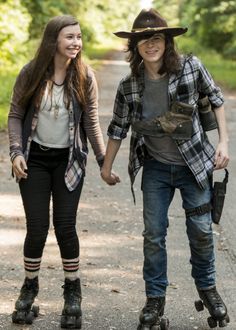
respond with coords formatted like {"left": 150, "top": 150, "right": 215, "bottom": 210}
{"left": 56, "top": 24, "right": 82, "bottom": 59}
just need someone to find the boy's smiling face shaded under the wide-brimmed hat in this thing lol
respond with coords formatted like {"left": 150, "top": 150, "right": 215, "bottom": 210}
{"left": 137, "top": 33, "right": 165, "bottom": 63}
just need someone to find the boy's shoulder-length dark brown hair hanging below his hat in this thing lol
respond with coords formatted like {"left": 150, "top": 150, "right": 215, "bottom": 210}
{"left": 127, "top": 34, "right": 180, "bottom": 77}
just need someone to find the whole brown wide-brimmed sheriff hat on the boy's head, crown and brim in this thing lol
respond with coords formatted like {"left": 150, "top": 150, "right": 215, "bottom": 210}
{"left": 114, "top": 8, "right": 188, "bottom": 39}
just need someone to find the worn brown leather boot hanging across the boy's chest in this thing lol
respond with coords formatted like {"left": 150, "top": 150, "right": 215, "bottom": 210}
{"left": 132, "top": 101, "right": 194, "bottom": 140}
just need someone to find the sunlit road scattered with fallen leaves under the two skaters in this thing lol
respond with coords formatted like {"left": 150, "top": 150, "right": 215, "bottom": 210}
{"left": 0, "top": 50, "right": 236, "bottom": 330}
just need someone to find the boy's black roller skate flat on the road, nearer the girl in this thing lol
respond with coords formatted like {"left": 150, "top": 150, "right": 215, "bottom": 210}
{"left": 137, "top": 297, "right": 169, "bottom": 330}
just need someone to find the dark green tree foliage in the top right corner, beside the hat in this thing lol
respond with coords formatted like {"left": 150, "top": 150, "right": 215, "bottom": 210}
{"left": 180, "top": 0, "right": 236, "bottom": 58}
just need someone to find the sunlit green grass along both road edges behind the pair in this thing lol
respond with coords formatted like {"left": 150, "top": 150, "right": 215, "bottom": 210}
{"left": 0, "top": 38, "right": 236, "bottom": 129}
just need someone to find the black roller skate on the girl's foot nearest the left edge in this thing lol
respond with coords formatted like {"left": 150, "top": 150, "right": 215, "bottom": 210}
{"left": 12, "top": 277, "right": 39, "bottom": 324}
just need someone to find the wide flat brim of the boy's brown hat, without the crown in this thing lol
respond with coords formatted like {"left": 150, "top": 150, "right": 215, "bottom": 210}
{"left": 114, "top": 27, "right": 188, "bottom": 39}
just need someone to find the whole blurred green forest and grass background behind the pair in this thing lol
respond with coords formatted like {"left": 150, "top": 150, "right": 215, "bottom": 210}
{"left": 0, "top": 0, "right": 236, "bottom": 129}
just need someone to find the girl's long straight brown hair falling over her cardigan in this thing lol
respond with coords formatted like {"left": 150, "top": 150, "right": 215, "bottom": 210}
{"left": 20, "top": 15, "right": 87, "bottom": 107}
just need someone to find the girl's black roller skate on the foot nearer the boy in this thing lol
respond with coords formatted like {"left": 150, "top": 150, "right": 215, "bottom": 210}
{"left": 61, "top": 278, "right": 82, "bottom": 329}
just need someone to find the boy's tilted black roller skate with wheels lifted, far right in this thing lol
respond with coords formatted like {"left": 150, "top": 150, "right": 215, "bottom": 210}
{"left": 195, "top": 287, "right": 230, "bottom": 328}
